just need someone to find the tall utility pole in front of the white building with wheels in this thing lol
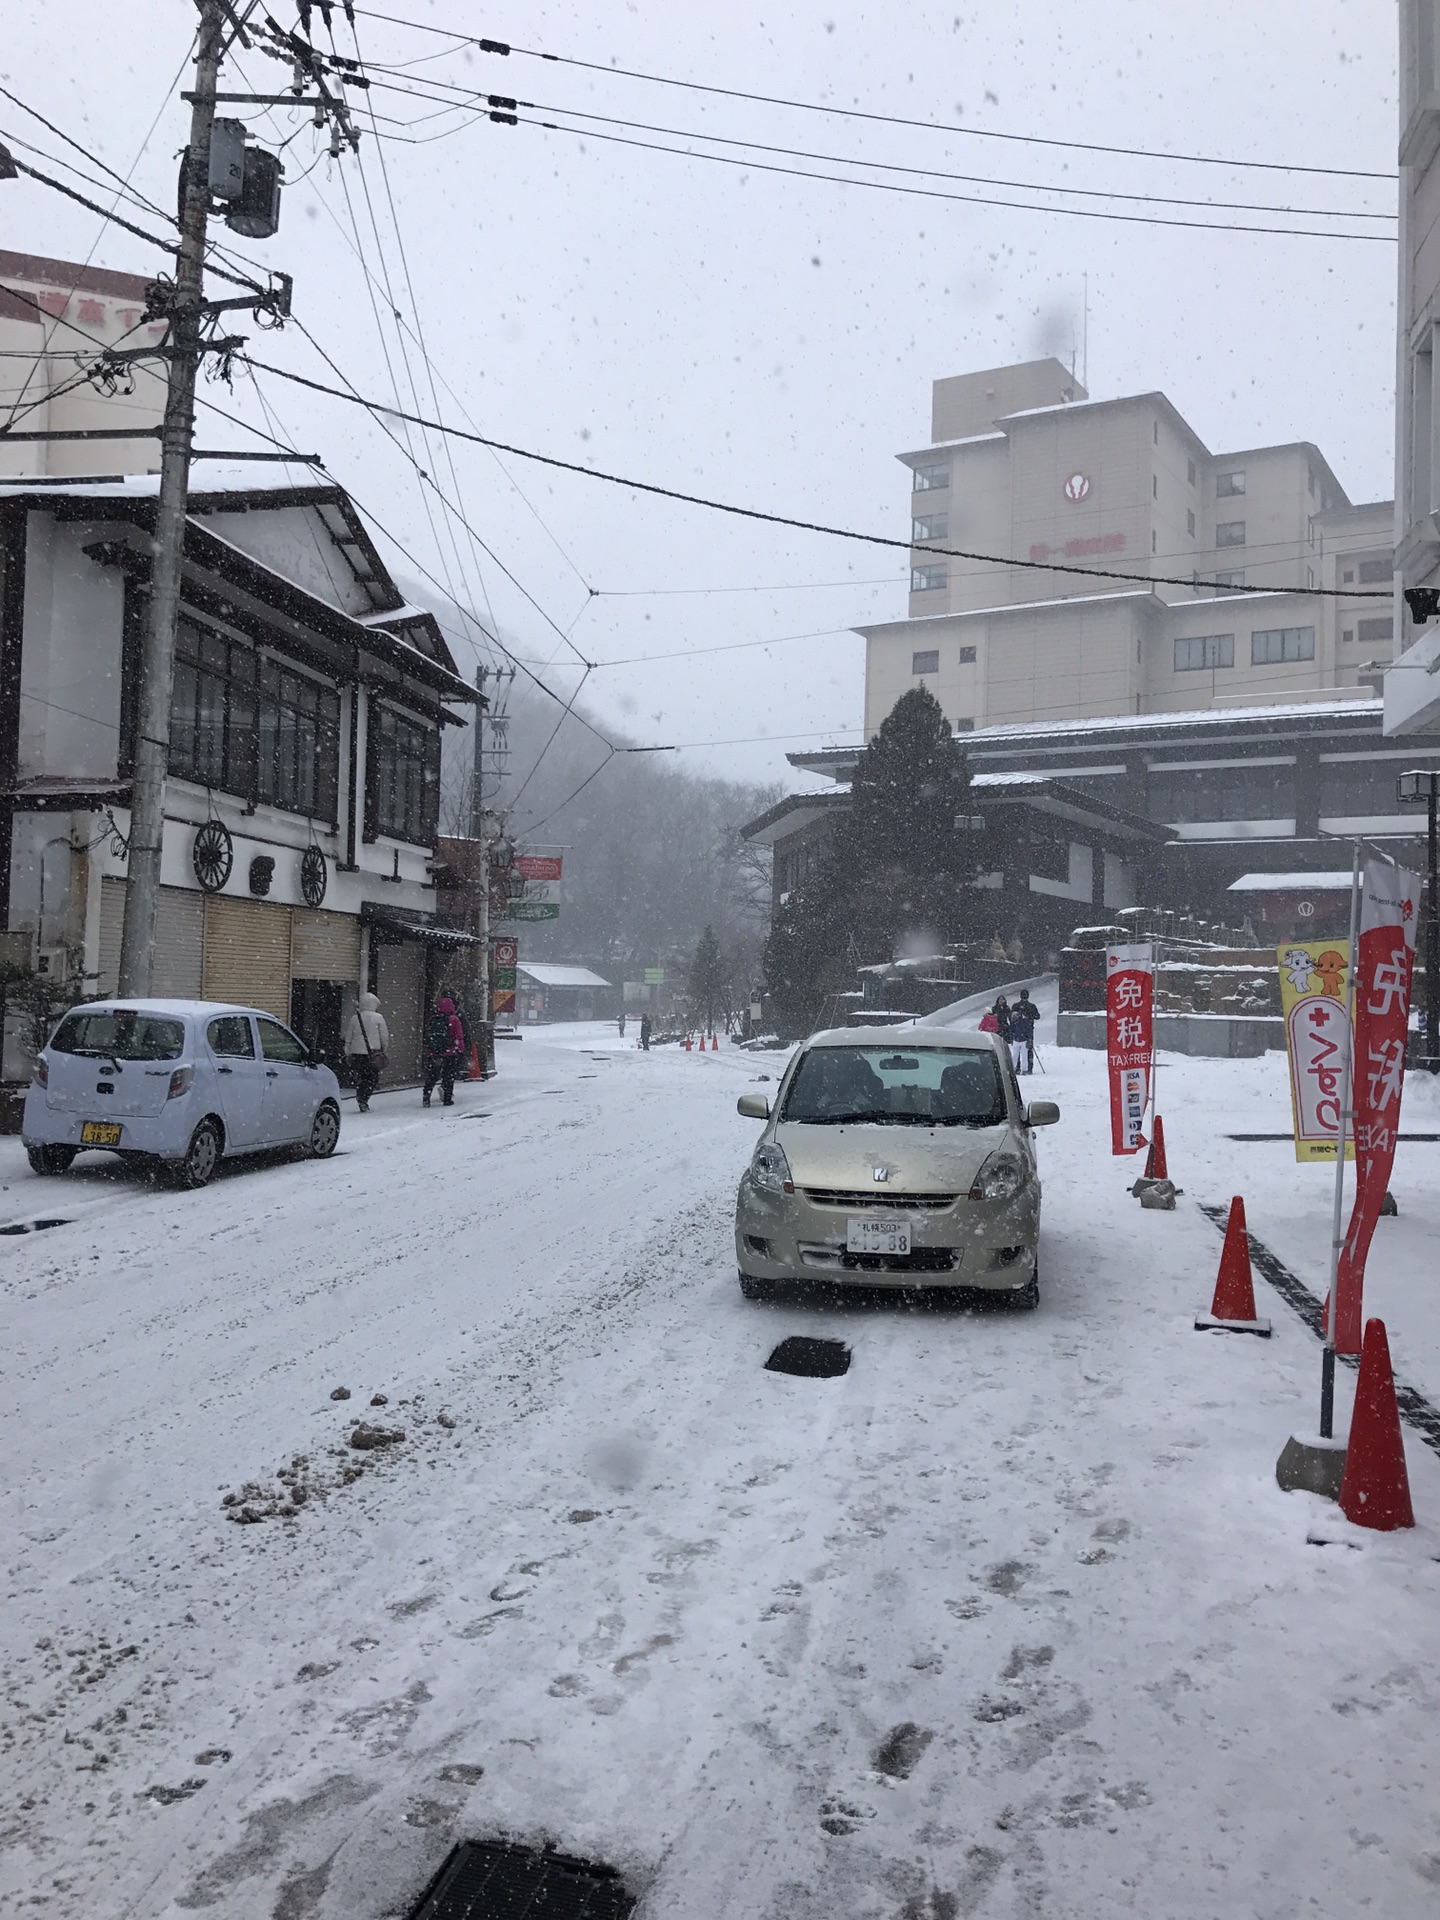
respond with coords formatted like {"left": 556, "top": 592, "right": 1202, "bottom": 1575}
{"left": 119, "top": 0, "right": 225, "bottom": 998}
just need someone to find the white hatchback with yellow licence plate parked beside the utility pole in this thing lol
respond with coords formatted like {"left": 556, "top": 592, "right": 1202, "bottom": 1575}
{"left": 21, "top": 1000, "right": 340, "bottom": 1187}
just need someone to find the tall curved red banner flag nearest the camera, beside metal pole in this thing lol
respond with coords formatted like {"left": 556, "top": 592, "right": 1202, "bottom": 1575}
{"left": 1334, "top": 860, "right": 1421, "bottom": 1354}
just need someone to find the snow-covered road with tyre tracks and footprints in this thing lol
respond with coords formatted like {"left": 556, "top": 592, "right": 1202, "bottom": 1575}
{"left": 0, "top": 1027, "right": 1440, "bottom": 1920}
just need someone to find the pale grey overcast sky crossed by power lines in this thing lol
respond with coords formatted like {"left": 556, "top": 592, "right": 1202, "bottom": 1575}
{"left": 0, "top": 0, "right": 1396, "bottom": 780}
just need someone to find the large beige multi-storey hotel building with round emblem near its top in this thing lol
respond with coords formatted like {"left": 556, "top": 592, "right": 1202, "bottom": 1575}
{"left": 858, "top": 359, "right": 1394, "bottom": 735}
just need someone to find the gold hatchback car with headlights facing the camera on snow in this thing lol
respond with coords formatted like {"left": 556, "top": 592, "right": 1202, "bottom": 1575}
{"left": 735, "top": 1025, "right": 1060, "bottom": 1308}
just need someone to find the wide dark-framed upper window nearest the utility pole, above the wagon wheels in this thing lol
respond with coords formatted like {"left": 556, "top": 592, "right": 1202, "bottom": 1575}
{"left": 169, "top": 620, "right": 340, "bottom": 822}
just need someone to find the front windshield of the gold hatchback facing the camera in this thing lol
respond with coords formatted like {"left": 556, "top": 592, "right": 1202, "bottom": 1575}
{"left": 780, "top": 1046, "right": 1006, "bottom": 1127}
